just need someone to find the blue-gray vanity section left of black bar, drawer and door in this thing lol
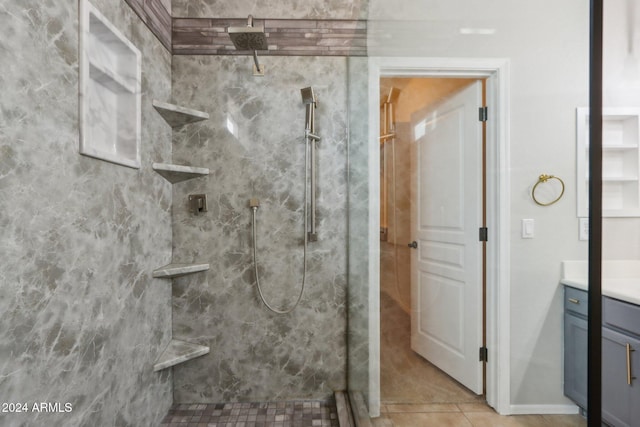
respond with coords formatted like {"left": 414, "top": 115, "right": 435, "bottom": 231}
{"left": 564, "top": 286, "right": 588, "bottom": 409}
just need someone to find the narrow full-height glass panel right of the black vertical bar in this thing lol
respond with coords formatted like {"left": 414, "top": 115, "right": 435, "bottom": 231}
{"left": 601, "top": 0, "right": 640, "bottom": 426}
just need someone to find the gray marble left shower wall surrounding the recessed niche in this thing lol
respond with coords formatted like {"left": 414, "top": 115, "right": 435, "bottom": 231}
{"left": 0, "top": 0, "right": 172, "bottom": 426}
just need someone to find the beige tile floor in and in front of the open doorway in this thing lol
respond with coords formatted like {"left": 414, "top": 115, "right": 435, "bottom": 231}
{"left": 380, "top": 292, "right": 587, "bottom": 427}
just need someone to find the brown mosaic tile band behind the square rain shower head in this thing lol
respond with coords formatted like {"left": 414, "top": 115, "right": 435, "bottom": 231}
{"left": 172, "top": 18, "right": 367, "bottom": 56}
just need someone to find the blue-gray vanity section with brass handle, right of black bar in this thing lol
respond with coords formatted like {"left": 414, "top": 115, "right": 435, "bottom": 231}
{"left": 602, "top": 297, "right": 640, "bottom": 427}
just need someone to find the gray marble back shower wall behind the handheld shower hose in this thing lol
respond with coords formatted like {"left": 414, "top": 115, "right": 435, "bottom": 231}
{"left": 173, "top": 56, "right": 347, "bottom": 403}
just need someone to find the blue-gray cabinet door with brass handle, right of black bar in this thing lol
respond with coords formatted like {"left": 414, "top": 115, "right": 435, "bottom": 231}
{"left": 602, "top": 328, "right": 640, "bottom": 427}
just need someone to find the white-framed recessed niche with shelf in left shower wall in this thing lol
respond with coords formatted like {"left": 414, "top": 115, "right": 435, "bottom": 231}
{"left": 79, "top": 0, "right": 142, "bottom": 169}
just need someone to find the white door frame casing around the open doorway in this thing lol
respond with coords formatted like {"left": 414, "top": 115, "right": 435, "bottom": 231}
{"left": 368, "top": 57, "right": 511, "bottom": 417}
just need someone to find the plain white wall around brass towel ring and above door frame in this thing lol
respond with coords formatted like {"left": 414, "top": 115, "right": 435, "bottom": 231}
{"left": 369, "top": 0, "right": 589, "bottom": 412}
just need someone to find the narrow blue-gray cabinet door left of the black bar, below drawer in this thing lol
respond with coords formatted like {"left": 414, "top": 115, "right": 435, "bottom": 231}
{"left": 564, "top": 313, "right": 588, "bottom": 409}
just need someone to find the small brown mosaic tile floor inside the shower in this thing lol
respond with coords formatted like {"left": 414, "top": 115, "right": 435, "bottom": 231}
{"left": 161, "top": 401, "right": 339, "bottom": 427}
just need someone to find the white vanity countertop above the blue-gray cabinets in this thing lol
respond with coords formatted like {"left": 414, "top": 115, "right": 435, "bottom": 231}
{"left": 560, "top": 260, "right": 640, "bottom": 305}
